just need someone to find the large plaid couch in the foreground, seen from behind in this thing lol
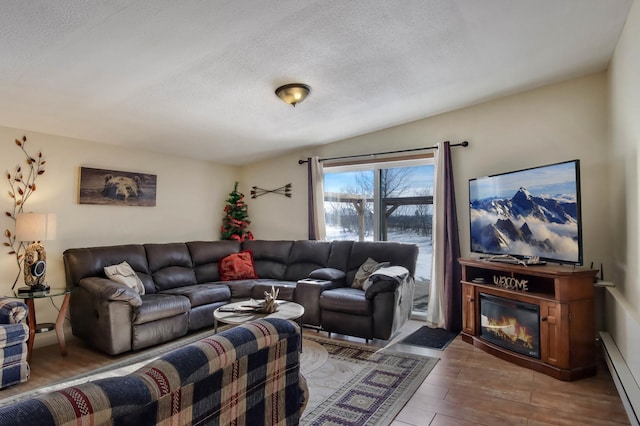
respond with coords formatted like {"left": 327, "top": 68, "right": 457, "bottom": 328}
{"left": 0, "top": 319, "right": 308, "bottom": 426}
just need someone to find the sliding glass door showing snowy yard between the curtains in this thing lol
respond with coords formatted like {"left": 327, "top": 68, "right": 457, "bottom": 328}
{"left": 324, "top": 159, "right": 433, "bottom": 313}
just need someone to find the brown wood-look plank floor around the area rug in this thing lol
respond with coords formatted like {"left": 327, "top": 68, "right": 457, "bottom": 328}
{"left": 0, "top": 321, "right": 629, "bottom": 426}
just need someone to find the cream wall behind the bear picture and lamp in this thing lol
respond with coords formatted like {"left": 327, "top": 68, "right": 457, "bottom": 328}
{"left": 0, "top": 127, "right": 238, "bottom": 346}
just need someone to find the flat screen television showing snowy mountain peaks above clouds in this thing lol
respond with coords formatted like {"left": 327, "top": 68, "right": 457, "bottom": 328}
{"left": 469, "top": 160, "right": 582, "bottom": 265}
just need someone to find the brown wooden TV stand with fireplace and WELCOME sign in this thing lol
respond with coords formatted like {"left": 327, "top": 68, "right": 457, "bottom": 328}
{"left": 458, "top": 258, "right": 598, "bottom": 380}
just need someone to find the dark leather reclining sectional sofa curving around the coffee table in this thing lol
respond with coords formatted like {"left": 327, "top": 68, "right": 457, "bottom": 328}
{"left": 64, "top": 240, "right": 418, "bottom": 355}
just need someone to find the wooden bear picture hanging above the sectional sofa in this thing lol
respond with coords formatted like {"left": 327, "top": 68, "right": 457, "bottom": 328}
{"left": 78, "top": 167, "right": 157, "bottom": 207}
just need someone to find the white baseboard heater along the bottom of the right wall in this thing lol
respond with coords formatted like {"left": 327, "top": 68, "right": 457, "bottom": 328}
{"left": 600, "top": 331, "right": 640, "bottom": 426}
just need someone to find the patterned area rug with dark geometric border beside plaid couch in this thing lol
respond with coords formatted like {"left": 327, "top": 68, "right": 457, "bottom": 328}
{"left": 300, "top": 335, "right": 438, "bottom": 426}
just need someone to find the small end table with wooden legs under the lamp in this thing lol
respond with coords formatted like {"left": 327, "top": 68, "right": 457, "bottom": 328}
{"left": 10, "top": 288, "right": 71, "bottom": 362}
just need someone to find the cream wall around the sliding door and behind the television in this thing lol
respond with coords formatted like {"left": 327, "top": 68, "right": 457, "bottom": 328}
{"left": 242, "top": 73, "right": 611, "bottom": 271}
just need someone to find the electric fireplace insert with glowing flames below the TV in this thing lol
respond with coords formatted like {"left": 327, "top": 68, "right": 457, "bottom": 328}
{"left": 480, "top": 293, "right": 540, "bottom": 359}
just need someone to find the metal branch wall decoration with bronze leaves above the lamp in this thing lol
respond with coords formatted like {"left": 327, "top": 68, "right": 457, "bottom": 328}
{"left": 4, "top": 136, "right": 46, "bottom": 287}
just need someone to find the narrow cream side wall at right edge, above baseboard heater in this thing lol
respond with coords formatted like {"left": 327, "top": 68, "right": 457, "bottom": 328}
{"left": 606, "top": 1, "right": 640, "bottom": 383}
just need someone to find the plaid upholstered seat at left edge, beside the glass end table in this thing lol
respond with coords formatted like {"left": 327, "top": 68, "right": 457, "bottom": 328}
{"left": 0, "top": 297, "right": 30, "bottom": 388}
